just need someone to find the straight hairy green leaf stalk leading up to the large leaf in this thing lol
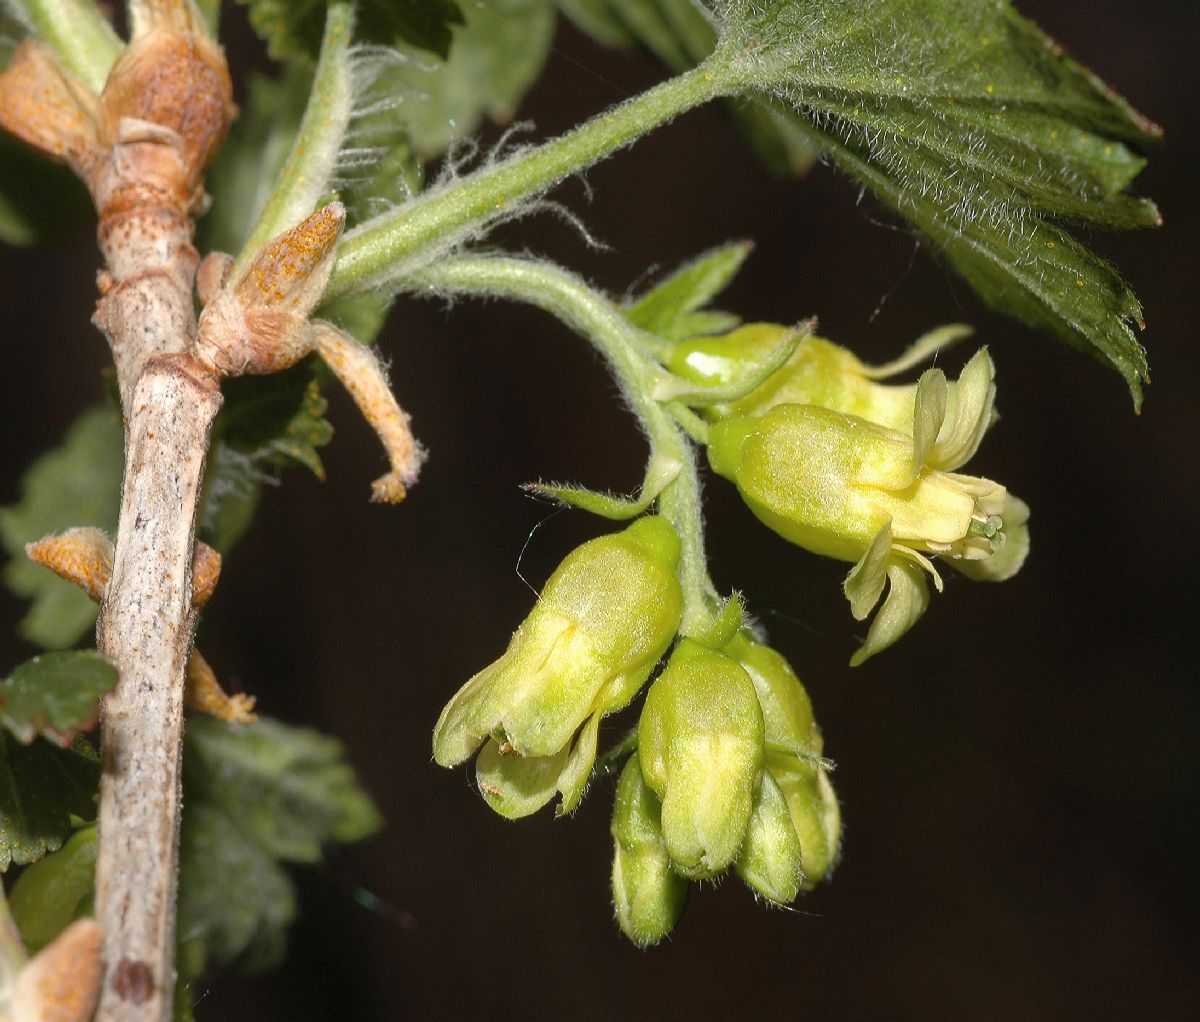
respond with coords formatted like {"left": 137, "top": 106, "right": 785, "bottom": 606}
{"left": 325, "top": 62, "right": 721, "bottom": 301}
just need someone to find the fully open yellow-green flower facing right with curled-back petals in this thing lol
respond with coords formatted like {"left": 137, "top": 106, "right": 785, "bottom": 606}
{"left": 708, "top": 362, "right": 1028, "bottom": 665}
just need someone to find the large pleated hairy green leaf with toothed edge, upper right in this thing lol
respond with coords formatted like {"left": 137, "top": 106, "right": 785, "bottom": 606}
{"left": 712, "top": 0, "right": 1159, "bottom": 407}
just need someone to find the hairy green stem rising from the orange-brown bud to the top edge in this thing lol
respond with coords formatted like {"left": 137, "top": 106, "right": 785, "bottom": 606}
{"left": 232, "top": 0, "right": 354, "bottom": 275}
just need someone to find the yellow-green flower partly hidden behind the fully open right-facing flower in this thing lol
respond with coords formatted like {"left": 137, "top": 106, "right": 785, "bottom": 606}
{"left": 666, "top": 323, "right": 991, "bottom": 433}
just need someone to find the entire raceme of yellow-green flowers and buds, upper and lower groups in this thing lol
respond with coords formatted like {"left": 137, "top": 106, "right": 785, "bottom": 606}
{"left": 433, "top": 324, "right": 1028, "bottom": 946}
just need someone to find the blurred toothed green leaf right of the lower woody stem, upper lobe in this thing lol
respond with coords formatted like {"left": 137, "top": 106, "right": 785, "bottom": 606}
{"left": 184, "top": 719, "right": 380, "bottom": 862}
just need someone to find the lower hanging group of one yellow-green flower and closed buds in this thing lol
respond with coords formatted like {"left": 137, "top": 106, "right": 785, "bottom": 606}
{"left": 433, "top": 516, "right": 840, "bottom": 944}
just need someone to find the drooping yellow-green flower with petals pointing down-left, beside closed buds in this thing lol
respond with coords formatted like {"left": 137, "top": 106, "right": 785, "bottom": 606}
{"left": 433, "top": 516, "right": 683, "bottom": 817}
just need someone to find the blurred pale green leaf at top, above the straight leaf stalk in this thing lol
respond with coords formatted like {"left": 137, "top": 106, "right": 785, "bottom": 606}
{"left": 392, "top": 0, "right": 554, "bottom": 160}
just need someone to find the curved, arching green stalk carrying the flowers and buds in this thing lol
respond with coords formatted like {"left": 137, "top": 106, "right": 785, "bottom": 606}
{"left": 404, "top": 256, "right": 719, "bottom": 636}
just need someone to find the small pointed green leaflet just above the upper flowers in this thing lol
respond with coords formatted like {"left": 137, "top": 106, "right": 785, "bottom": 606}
{"left": 625, "top": 241, "right": 754, "bottom": 341}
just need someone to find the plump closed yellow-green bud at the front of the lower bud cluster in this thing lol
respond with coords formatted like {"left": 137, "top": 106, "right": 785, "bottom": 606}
{"left": 638, "top": 639, "right": 763, "bottom": 879}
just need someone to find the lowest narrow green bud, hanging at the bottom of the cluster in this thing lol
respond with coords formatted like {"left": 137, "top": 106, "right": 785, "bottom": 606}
{"left": 612, "top": 756, "right": 688, "bottom": 948}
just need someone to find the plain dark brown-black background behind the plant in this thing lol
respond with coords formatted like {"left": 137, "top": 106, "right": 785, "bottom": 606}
{"left": 0, "top": 0, "right": 1200, "bottom": 1020}
